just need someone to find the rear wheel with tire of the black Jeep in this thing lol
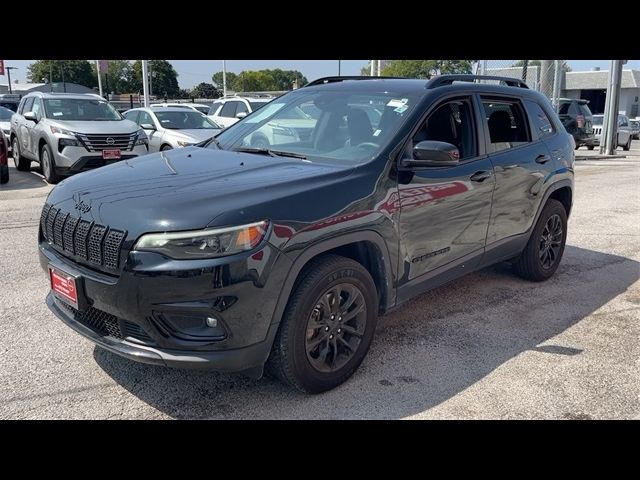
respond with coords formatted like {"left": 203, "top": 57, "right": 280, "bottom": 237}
{"left": 513, "top": 198, "right": 567, "bottom": 282}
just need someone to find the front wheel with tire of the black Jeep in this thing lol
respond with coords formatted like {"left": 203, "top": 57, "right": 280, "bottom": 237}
{"left": 266, "top": 254, "right": 378, "bottom": 393}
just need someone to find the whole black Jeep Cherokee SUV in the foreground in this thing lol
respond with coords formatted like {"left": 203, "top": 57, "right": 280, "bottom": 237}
{"left": 39, "top": 75, "right": 574, "bottom": 392}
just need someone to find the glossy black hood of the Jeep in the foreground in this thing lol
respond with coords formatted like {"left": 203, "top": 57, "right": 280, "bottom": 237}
{"left": 47, "top": 147, "right": 353, "bottom": 237}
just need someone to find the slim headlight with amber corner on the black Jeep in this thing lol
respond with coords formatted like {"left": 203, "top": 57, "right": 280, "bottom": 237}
{"left": 134, "top": 221, "right": 269, "bottom": 260}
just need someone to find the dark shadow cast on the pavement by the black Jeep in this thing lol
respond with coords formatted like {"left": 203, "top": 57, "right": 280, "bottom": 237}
{"left": 94, "top": 245, "right": 640, "bottom": 419}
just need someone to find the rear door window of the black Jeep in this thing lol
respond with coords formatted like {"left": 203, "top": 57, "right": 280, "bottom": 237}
{"left": 482, "top": 97, "right": 530, "bottom": 152}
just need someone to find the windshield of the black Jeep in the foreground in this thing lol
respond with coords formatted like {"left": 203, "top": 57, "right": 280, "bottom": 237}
{"left": 212, "top": 89, "right": 417, "bottom": 165}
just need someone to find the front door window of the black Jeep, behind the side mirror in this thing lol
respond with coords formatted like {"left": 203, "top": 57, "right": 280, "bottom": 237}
{"left": 412, "top": 97, "right": 478, "bottom": 159}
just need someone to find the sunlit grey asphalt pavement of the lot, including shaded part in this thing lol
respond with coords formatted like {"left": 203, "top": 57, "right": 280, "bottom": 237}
{"left": 0, "top": 141, "right": 640, "bottom": 419}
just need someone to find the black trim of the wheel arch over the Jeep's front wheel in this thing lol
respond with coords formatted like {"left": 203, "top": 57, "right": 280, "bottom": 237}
{"left": 272, "top": 230, "right": 395, "bottom": 324}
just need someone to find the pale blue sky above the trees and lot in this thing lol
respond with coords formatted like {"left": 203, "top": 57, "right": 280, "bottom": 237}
{"left": 0, "top": 60, "right": 640, "bottom": 88}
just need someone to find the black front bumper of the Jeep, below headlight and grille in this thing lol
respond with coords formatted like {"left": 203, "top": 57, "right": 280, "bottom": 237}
{"left": 39, "top": 237, "right": 291, "bottom": 371}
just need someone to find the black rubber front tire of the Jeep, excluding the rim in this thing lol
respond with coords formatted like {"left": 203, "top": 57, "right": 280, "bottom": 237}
{"left": 284, "top": 268, "right": 377, "bottom": 392}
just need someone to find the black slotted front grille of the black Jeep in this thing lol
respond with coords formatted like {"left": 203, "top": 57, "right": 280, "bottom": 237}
{"left": 40, "top": 204, "right": 127, "bottom": 273}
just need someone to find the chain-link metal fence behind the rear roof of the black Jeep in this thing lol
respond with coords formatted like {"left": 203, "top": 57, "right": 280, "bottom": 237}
{"left": 474, "top": 60, "right": 567, "bottom": 107}
